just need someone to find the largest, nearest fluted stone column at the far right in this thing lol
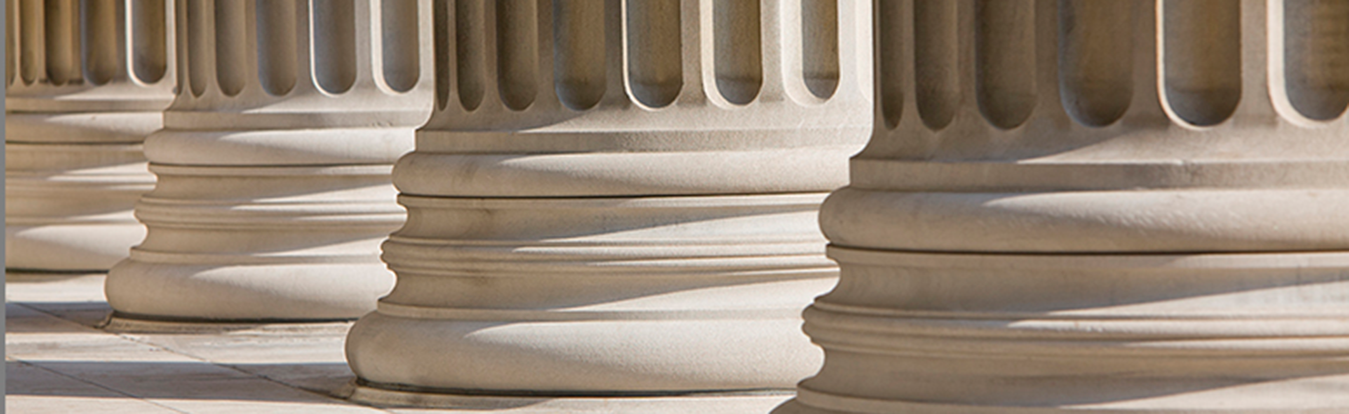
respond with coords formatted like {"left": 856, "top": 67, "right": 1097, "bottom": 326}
{"left": 776, "top": 0, "right": 1349, "bottom": 414}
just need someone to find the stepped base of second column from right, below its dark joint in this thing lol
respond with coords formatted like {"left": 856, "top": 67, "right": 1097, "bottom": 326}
{"left": 347, "top": 193, "right": 836, "bottom": 413}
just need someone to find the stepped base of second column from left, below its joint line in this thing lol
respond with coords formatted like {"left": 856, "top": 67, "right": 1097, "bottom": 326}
{"left": 105, "top": 165, "right": 405, "bottom": 322}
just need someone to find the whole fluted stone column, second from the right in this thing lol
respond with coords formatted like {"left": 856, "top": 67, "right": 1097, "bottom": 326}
{"left": 347, "top": 0, "right": 870, "bottom": 413}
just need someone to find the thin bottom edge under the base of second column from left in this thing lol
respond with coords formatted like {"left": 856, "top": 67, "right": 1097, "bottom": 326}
{"left": 97, "top": 312, "right": 352, "bottom": 334}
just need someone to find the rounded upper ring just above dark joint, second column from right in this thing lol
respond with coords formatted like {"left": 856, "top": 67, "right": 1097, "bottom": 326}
{"left": 394, "top": 146, "right": 857, "bottom": 196}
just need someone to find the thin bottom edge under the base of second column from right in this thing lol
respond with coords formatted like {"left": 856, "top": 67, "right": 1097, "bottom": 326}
{"left": 339, "top": 379, "right": 792, "bottom": 414}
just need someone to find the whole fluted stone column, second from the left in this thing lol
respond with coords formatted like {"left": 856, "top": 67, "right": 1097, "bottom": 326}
{"left": 107, "top": 0, "right": 433, "bottom": 322}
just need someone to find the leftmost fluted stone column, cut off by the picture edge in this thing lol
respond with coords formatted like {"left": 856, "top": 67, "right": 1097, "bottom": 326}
{"left": 4, "top": 0, "right": 174, "bottom": 271}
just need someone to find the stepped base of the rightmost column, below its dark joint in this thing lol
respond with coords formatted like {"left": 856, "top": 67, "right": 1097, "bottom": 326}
{"left": 774, "top": 247, "right": 1349, "bottom": 414}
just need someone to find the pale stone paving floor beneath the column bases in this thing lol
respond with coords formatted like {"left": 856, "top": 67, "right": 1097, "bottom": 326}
{"left": 4, "top": 272, "right": 791, "bottom": 414}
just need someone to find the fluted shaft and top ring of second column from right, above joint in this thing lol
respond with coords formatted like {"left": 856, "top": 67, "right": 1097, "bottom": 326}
{"left": 394, "top": 0, "right": 870, "bottom": 197}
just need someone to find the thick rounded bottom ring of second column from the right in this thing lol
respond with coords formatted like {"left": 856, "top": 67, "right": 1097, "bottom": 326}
{"left": 347, "top": 311, "right": 827, "bottom": 395}
